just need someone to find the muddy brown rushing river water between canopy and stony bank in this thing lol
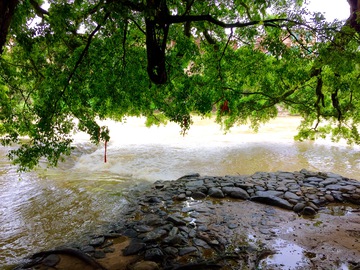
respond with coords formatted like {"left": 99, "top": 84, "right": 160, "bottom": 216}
{"left": 0, "top": 117, "right": 360, "bottom": 269}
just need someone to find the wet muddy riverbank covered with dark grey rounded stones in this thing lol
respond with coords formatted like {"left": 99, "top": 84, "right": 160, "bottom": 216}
{"left": 17, "top": 170, "right": 360, "bottom": 270}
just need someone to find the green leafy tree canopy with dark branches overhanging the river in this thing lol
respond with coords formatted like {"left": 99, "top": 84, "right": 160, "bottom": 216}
{"left": 0, "top": 0, "right": 360, "bottom": 170}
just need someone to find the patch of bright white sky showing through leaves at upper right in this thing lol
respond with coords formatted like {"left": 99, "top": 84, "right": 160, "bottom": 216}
{"left": 308, "top": 0, "right": 350, "bottom": 21}
